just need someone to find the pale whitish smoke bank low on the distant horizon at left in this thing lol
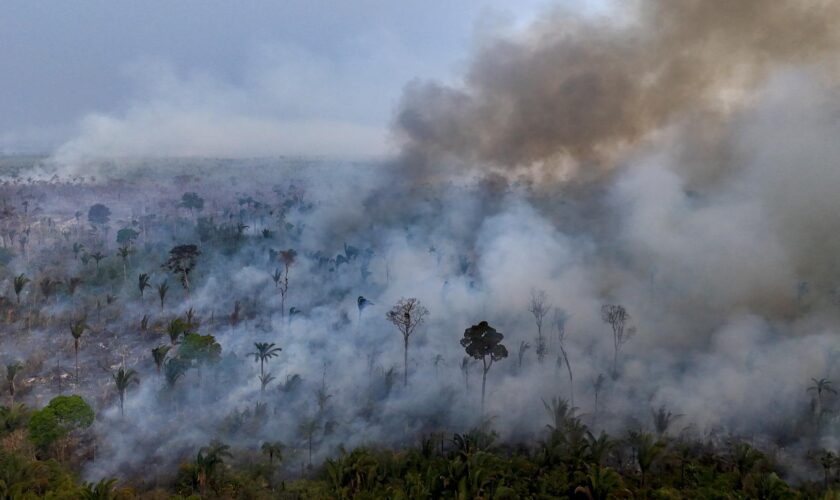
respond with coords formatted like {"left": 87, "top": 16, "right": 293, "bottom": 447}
{"left": 52, "top": 51, "right": 388, "bottom": 174}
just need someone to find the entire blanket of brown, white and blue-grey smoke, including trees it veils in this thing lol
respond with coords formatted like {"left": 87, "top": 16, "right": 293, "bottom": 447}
{"left": 0, "top": 0, "right": 840, "bottom": 494}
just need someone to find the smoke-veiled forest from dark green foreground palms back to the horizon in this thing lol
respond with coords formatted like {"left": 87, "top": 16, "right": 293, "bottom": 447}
{"left": 0, "top": 154, "right": 840, "bottom": 499}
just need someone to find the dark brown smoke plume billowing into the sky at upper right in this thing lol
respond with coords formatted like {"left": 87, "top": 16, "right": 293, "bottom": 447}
{"left": 396, "top": 0, "right": 840, "bottom": 180}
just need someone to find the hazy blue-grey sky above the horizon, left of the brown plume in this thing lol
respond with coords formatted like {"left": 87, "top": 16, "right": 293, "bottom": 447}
{"left": 0, "top": 0, "right": 560, "bottom": 155}
